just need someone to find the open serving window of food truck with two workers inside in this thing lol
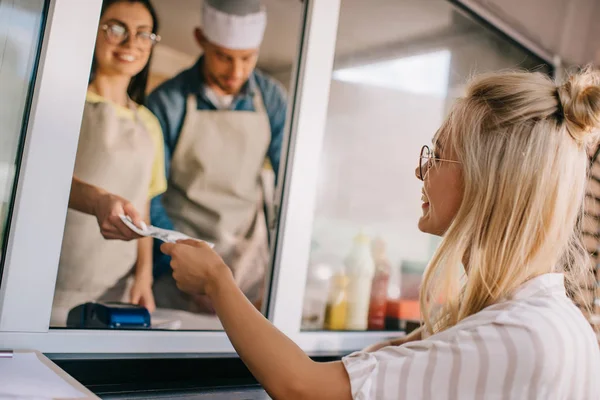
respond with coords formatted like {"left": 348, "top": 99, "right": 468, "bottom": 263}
{"left": 50, "top": 0, "right": 306, "bottom": 331}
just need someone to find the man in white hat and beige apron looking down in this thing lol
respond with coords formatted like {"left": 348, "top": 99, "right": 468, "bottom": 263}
{"left": 147, "top": 0, "right": 287, "bottom": 309}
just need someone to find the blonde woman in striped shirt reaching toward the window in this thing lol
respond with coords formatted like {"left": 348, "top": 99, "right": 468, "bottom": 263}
{"left": 163, "top": 72, "right": 600, "bottom": 400}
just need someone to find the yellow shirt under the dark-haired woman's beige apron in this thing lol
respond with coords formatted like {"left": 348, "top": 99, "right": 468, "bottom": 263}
{"left": 86, "top": 91, "right": 167, "bottom": 199}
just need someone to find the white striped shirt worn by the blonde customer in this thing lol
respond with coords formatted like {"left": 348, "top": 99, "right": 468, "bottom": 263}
{"left": 343, "top": 274, "right": 600, "bottom": 400}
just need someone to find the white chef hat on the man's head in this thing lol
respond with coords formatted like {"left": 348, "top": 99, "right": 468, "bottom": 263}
{"left": 202, "top": 0, "right": 267, "bottom": 50}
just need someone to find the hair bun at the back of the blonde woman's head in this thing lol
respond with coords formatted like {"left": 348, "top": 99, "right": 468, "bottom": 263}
{"left": 557, "top": 68, "right": 600, "bottom": 141}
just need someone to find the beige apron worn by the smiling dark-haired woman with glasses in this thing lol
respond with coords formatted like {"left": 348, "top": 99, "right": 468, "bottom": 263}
{"left": 52, "top": 102, "right": 155, "bottom": 324}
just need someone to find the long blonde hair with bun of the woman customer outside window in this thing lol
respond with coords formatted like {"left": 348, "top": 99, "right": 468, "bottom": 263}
{"left": 421, "top": 70, "right": 600, "bottom": 333}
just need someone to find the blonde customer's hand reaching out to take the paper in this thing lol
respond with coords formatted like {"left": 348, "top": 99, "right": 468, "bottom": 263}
{"left": 160, "top": 240, "right": 233, "bottom": 296}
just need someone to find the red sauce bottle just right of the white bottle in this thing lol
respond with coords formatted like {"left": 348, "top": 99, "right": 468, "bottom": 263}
{"left": 368, "top": 238, "right": 391, "bottom": 331}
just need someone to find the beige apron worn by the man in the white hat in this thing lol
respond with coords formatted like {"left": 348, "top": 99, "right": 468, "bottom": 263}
{"left": 155, "top": 91, "right": 273, "bottom": 311}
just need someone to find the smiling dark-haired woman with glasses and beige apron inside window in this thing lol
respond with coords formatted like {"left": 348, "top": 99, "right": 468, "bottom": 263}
{"left": 51, "top": 0, "right": 166, "bottom": 326}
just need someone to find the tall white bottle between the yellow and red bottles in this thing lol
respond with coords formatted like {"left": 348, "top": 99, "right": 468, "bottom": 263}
{"left": 344, "top": 234, "right": 375, "bottom": 331}
